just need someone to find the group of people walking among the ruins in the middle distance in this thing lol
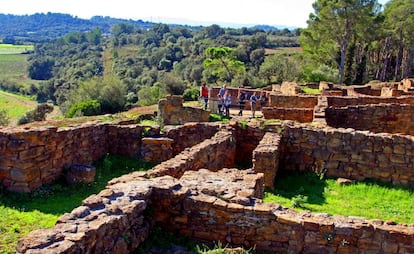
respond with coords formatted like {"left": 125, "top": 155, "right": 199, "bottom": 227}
{"left": 200, "top": 84, "right": 266, "bottom": 117}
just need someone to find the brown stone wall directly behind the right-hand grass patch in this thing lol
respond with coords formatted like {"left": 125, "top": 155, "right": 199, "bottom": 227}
{"left": 279, "top": 125, "right": 414, "bottom": 184}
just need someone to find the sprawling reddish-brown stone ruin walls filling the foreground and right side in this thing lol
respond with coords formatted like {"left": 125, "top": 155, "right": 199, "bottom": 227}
{"left": 0, "top": 80, "right": 414, "bottom": 253}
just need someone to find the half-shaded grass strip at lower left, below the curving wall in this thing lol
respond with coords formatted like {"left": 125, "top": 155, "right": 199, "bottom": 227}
{"left": 0, "top": 156, "right": 154, "bottom": 253}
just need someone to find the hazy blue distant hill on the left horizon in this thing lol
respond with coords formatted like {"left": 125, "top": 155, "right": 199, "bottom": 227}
{"left": 0, "top": 12, "right": 284, "bottom": 44}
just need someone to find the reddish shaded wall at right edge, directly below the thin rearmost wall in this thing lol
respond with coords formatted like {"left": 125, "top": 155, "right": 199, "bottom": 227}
{"left": 325, "top": 104, "right": 414, "bottom": 135}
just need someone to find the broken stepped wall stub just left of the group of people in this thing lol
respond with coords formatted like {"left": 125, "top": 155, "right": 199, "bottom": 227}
{"left": 158, "top": 95, "right": 210, "bottom": 125}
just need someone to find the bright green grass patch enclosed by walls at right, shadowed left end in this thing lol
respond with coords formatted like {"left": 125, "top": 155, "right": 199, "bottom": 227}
{"left": 264, "top": 173, "right": 414, "bottom": 224}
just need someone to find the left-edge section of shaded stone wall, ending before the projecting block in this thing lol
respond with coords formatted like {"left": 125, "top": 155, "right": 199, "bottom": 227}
{"left": 0, "top": 123, "right": 146, "bottom": 192}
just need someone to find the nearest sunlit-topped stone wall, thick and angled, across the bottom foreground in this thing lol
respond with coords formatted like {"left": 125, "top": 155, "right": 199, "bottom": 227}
{"left": 17, "top": 157, "right": 414, "bottom": 253}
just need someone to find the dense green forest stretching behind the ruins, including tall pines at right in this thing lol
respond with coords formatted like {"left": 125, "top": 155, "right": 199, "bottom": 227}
{"left": 0, "top": 0, "right": 414, "bottom": 116}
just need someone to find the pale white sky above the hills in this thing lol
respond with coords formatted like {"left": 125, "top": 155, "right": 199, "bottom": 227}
{"left": 0, "top": 0, "right": 389, "bottom": 28}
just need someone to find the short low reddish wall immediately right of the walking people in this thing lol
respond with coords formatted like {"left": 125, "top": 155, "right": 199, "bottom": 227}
{"left": 268, "top": 94, "right": 318, "bottom": 109}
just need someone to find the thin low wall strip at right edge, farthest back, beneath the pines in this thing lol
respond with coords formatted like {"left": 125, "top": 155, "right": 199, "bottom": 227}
{"left": 327, "top": 96, "right": 414, "bottom": 107}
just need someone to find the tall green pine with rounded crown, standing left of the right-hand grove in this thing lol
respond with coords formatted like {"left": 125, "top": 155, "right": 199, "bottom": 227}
{"left": 300, "top": 0, "right": 379, "bottom": 84}
